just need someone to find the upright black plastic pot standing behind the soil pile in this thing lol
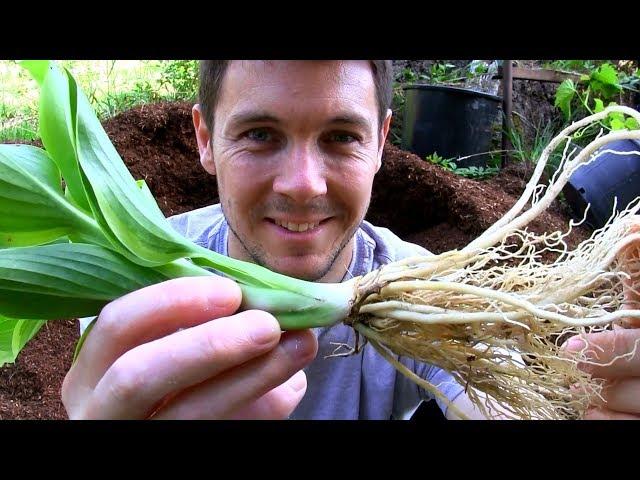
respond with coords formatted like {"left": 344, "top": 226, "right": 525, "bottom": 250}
{"left": 402, "top": 84, "right": 502, "bottom": 167}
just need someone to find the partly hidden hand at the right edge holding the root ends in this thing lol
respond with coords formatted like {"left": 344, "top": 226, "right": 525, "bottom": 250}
{"left": 567, "top": 221, "right": 640, "bottom": 420}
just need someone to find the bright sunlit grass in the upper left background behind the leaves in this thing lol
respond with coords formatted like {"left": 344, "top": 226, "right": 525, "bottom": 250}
{"left": 0, "top": 60, "right": 195, "bottom": 142}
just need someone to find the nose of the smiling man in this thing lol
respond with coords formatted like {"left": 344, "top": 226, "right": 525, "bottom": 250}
{"left": 273, "top": 143, "right": 327, "bottom": 203}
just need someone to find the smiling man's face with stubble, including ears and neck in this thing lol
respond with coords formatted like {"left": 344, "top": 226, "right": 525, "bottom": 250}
{"left": 194, "top": 61, "right": 390, "bottom": 281}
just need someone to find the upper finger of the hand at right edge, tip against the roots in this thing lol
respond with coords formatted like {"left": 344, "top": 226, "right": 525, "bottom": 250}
{"left": 566, "top": 329, "right": 640, "bottom": 378}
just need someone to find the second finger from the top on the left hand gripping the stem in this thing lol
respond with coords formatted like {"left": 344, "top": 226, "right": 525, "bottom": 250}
{"left": 79, "top": 310, "right": 280, "bottom": 419}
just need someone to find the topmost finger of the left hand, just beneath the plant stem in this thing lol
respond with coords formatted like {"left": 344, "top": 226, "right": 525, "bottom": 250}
{"left": 70, "top": 276, "right": 242, "bottom": 387}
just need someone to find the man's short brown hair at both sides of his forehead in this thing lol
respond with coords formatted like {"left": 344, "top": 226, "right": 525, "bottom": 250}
{"left": 198, "top": 60, "right": 393, "bottom": 131}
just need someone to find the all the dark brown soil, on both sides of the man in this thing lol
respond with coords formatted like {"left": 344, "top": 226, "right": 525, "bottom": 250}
{"left": 0, "top": 103, "right": 587, "bottom": 419}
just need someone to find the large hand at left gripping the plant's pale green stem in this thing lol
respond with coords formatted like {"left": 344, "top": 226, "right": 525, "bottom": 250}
{"left": 62, "top": 276, "right": 318, "bottom": 419}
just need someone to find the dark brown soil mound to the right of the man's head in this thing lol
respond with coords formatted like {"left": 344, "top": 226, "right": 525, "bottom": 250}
{"left": 367, "top": 145, "right": 588, "bottom": 253}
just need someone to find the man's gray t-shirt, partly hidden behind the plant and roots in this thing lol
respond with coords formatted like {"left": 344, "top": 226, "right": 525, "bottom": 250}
{"left": 169, "top": 204, "right": 464, "bottom": 420}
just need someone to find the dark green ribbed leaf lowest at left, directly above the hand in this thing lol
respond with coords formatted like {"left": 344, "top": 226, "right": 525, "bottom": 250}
{"left": 0, "top": 243, "right": 172, "bottom": 320}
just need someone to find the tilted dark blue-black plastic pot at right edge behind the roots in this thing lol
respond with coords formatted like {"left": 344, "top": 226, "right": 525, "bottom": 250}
{"left": 563, "top": 140, "right": 640, "bottom": 228}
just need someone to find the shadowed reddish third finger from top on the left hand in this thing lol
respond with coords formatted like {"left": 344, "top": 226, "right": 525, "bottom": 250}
{"left": 153, "top": 330, "right": 318, "bottom": 419}
